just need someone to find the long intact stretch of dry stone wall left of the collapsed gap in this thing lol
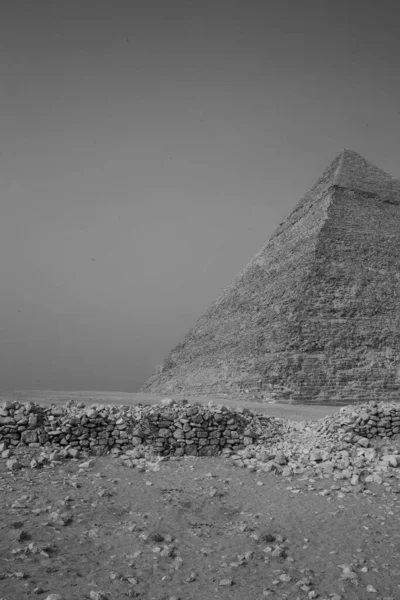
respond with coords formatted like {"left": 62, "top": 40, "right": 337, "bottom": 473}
{"left": 0, "top": 401, "right": 288, "bottom": 456}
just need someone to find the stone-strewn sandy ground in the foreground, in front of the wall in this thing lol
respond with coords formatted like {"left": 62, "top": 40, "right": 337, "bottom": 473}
{"left": 0, "top": 450, "right": 400, "bottom": 600}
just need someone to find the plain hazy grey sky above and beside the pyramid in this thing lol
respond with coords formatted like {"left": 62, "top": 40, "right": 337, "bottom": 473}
{"left": 0, "top": 0, "right": 400, "bottom": 392}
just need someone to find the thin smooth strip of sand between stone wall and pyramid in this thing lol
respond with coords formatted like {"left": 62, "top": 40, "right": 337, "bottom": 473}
{"left": 0, "top": 390, "right": 340, "bottom": 421}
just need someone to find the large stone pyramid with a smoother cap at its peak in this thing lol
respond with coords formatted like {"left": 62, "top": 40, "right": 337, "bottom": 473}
{"left": 142, "top": 150, "right": 400, "bottom": 405}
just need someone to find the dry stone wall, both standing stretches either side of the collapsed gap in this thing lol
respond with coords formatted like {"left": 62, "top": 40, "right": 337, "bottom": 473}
{"left": 0, "top": 402, "right": 400, "bottom": 458}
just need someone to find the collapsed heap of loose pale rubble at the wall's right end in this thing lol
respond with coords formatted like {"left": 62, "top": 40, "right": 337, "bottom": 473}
{"left": 230, "top": 402, "right": 400, "bottom": 494}
